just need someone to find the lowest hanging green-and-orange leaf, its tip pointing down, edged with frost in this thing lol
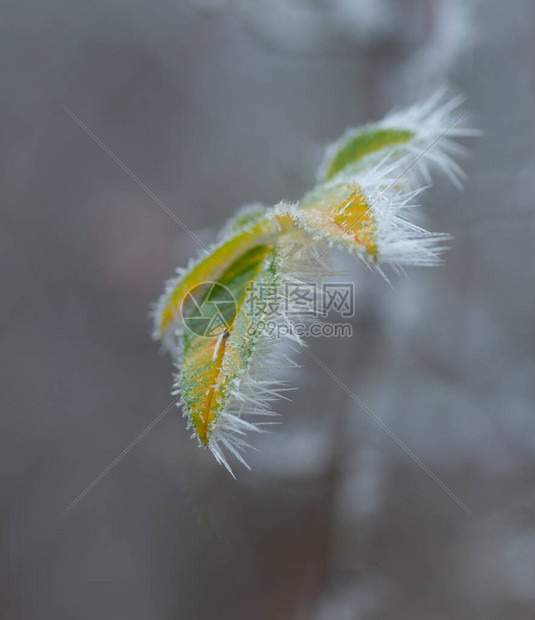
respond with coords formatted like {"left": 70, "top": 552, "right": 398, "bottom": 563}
{"left": 176, "top": 244, "right": 279, "bottom": 467}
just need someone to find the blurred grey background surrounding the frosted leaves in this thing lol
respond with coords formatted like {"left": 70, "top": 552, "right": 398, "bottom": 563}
{"left": 0, "top": 0, "right": 535, "bottom": 620}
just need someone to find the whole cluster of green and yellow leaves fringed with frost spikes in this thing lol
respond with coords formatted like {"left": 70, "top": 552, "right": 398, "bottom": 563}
{"left": 154, "top": 92, "right": 475, "bottom": 473}
